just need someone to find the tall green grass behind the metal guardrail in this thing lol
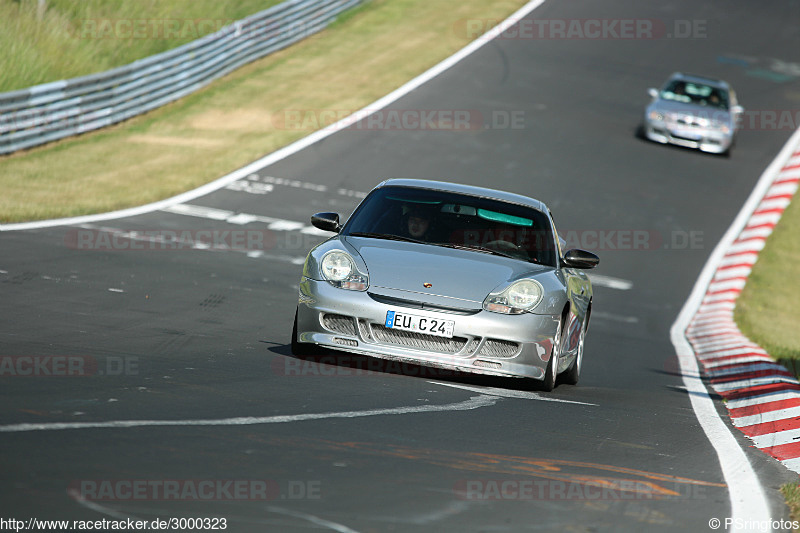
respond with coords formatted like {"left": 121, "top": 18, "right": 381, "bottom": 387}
{"left": 0, "top": 0, "right": 281, "bottom": 92}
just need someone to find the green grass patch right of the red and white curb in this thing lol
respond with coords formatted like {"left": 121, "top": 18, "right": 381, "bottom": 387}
{"left": 734, "top": 189, "right": 800, "bottom": 360}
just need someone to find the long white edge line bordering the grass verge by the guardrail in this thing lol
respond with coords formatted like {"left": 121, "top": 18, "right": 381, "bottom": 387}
{"left": 0, "top": 0, "right": 544, "bottom": 231}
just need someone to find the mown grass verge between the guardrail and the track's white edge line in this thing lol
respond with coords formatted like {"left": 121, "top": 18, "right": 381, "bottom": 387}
{"left": 0, "top": 0, "right": 525, "bottom": 222}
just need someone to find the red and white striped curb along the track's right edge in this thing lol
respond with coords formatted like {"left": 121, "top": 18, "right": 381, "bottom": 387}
{"left": 685, "top": 143, "right": 800, "bottom": 473}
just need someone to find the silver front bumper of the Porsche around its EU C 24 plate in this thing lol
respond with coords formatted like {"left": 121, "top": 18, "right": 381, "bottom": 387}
{"left": 297, "top": 278, "right": 560, "bottom": 380}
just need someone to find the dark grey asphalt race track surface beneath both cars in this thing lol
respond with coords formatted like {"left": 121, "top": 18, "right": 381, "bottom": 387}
{"left": 0, "top": 0, "right": 800, "bottom": 532}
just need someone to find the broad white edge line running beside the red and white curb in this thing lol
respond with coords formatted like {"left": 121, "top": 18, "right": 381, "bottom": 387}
{"left": 670, "top": 125, "right": 800, "bottom": 529}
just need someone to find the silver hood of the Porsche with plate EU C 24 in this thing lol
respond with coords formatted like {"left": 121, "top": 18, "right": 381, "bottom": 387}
{"left": 346, "top": 237, "right": 548, "bottom": 308}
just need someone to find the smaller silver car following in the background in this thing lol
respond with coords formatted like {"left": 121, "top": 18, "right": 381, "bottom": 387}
{"left": 644, "top": 72, "right": 744, "bottom": 154}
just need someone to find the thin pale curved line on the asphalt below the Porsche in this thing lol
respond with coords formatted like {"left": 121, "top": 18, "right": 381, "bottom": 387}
{"left": 0, "top": 394, "right": 498, "bottom": 433}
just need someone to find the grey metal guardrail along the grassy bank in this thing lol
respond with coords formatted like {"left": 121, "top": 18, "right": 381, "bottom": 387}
{"left": 0, "top": 0, "right": 363, "bottom": 155}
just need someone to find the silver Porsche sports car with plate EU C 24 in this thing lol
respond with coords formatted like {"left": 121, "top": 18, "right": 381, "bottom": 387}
{"left": 292, "top": 179, "right": 599, "bottom": 390}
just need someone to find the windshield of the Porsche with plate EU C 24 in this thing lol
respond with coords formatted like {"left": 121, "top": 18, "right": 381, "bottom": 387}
{"left": 342, "top": 187, "right": 557, "bottom": 266}
